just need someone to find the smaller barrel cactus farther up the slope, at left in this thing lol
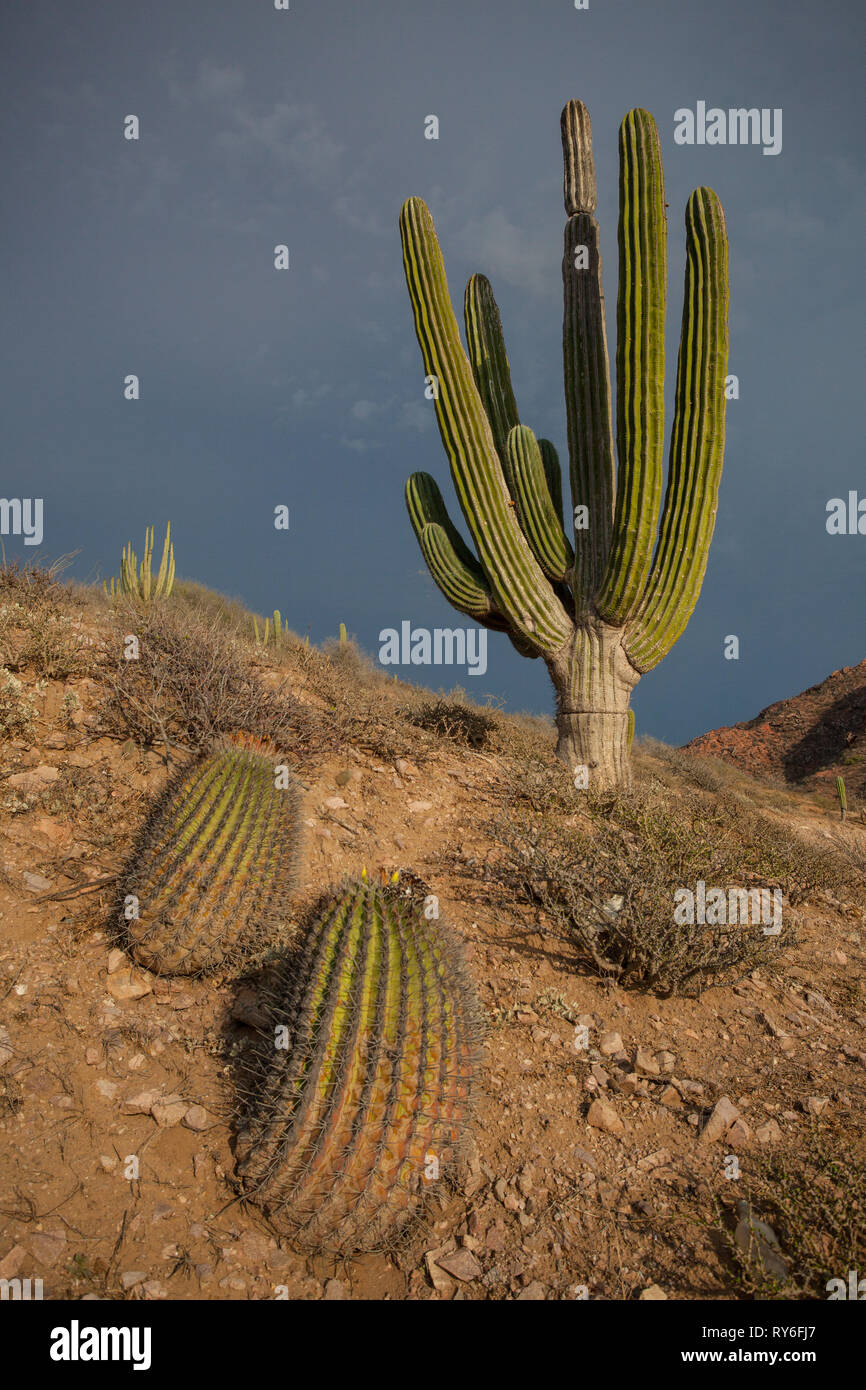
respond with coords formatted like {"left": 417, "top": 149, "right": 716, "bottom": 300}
{"left": 121, "top": 734, "right": 299, "bottom": 974}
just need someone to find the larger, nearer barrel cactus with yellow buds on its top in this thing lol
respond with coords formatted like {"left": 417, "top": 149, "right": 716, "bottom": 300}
{"left": 238, "top": 883, "right": 481, "bottom": 1252}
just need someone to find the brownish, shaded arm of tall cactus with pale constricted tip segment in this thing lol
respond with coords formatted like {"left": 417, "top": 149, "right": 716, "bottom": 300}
{"left": 560, "top": 101, "right": 614, "bottom": 614}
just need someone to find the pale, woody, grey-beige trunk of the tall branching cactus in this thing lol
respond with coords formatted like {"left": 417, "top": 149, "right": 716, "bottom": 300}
{"left": 546, "top": 620, "right": 638, "bottom": 790}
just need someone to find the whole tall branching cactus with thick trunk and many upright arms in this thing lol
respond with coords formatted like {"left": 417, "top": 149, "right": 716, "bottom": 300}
{"left": 400, "top": 101, "right": 728, "bottom": 788}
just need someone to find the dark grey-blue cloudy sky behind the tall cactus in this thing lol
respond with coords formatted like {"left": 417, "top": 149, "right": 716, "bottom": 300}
{"left": 0, "top": 0, "right": 866, "bottom": 742}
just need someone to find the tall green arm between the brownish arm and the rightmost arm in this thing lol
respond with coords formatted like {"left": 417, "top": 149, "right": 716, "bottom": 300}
{"left": 596, "top": 110, "right": 667, "bottom": 627}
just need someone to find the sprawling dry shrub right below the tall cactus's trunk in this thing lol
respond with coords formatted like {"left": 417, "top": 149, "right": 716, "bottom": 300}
{"left": 488, "top": 756, "right": 865, "bottom": 995}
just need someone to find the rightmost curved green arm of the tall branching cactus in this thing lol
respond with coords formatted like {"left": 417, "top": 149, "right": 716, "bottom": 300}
{"left": 626, "top": 188, "right": 728, "bottom": 671}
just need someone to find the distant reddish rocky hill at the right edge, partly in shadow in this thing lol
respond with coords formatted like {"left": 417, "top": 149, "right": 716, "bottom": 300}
{"left": 685, "top": 660, "right": 866, "bottom": 802}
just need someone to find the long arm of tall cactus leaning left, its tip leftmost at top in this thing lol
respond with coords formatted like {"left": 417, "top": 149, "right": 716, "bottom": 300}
{"left": 400, "top": 197, "right": 573, "bottom": 655}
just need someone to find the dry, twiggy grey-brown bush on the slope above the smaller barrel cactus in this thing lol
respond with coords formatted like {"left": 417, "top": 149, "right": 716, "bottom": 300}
{"left": 101, "top": 603, "right": 334, "bottom": 758}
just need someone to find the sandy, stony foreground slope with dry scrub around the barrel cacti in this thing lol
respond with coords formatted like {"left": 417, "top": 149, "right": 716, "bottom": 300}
{"left": 0, "top": 571, "right": 866, "bottom": 1300}
